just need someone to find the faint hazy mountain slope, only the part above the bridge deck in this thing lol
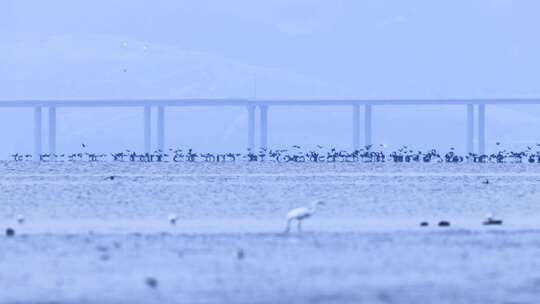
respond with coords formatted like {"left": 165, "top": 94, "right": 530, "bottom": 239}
{"left": 0, "top": 36, "right": 339, "bottom": 99}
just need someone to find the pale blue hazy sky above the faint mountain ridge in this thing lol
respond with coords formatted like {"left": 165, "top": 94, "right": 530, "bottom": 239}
{"left": 4, "top": 0, "right": 540, "bottom": 97}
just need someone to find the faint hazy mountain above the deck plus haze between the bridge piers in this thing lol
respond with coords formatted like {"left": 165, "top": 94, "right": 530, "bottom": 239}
{"left": 0, "top": 36, "right": 540, "bottom": 155}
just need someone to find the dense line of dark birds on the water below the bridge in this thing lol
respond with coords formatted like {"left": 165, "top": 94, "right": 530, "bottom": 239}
{"left": 12, "top": 143, "right": 540, "bottom": 163}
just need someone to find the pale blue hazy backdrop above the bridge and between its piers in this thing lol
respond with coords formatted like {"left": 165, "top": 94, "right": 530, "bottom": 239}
{"left": 0, "top": 0, "right": 540, "bottom": 155}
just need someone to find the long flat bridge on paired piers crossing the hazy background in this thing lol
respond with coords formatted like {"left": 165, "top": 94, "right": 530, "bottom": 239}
{"left": 0, "top": 98, "right": 540, "bottom": 160}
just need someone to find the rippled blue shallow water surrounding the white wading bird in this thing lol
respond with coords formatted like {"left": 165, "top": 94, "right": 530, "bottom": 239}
{"left": 0, "top": 162, "right": 540, "bottom": 303}
